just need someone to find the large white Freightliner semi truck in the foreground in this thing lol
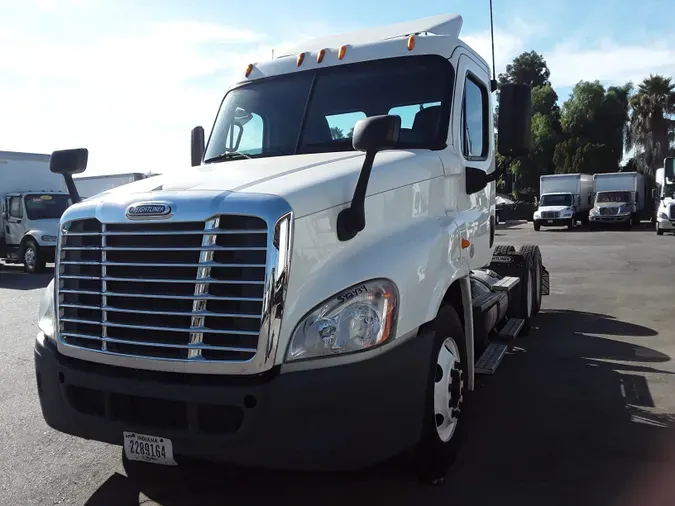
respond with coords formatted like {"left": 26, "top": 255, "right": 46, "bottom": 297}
{"left": 35, "top": 16, "right": 548, "bottom": 483}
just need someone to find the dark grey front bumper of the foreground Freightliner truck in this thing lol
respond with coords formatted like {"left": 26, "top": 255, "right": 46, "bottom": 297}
{"left": 35, "top": 336, "right": 432, "bottom": 470}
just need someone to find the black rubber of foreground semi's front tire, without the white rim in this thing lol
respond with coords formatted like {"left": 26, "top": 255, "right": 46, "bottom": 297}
{"left": 416, "top": 305, "right": 467, "bottom": 485}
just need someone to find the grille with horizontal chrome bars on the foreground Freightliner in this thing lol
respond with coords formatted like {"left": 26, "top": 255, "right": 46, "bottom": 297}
{"left": 58, "top": 215, "right": 268, "bottom": 362}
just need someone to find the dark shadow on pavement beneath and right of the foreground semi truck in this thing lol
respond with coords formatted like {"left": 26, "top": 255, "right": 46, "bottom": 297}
{"left": 82, "top": 311, "right": 675, "bottom": 506}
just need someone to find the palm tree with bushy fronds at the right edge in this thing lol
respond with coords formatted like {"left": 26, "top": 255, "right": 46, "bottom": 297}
{"left": 626, "top": 75, "right": 675, "bottom": 175}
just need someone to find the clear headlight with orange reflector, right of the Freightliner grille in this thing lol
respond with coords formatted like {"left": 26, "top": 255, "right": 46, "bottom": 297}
{"left": 286, "top": 279, "right": 398, "bottom": 362}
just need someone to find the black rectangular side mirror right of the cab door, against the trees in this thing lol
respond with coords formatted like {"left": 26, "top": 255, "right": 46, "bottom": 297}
{"left": 497, "top": 83, "right": 532, "bottom": 157}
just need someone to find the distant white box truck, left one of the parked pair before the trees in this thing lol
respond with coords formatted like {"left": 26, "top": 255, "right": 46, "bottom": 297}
{"left": 533, "top": 174, "right": 593, "bottom": 231}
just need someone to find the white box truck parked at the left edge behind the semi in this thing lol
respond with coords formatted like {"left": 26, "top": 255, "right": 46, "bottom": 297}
{"left": 0, "top": 151, "right": 70, "bottom": 273}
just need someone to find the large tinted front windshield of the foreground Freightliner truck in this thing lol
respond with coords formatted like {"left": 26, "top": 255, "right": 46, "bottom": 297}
{"left": 204, "top": 56, "right": 453, "bottom": 163}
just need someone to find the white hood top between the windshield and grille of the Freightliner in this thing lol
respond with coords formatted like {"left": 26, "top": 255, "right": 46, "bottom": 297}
{"left": 87, "top": 150, "right": 443, "bottom": 217}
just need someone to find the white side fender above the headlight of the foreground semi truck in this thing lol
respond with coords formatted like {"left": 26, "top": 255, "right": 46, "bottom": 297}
{"left": 275, "top": 198, "right": 469, "bottom": 363}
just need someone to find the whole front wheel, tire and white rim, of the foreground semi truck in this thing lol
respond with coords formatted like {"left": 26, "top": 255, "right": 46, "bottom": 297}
{"left": 417, "top": 305, "right": 467, "bottom": 485}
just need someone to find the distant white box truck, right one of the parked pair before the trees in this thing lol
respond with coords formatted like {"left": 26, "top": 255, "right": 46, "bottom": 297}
{"left": 589, "top": 172, "right": 645, "bottom": 229}
